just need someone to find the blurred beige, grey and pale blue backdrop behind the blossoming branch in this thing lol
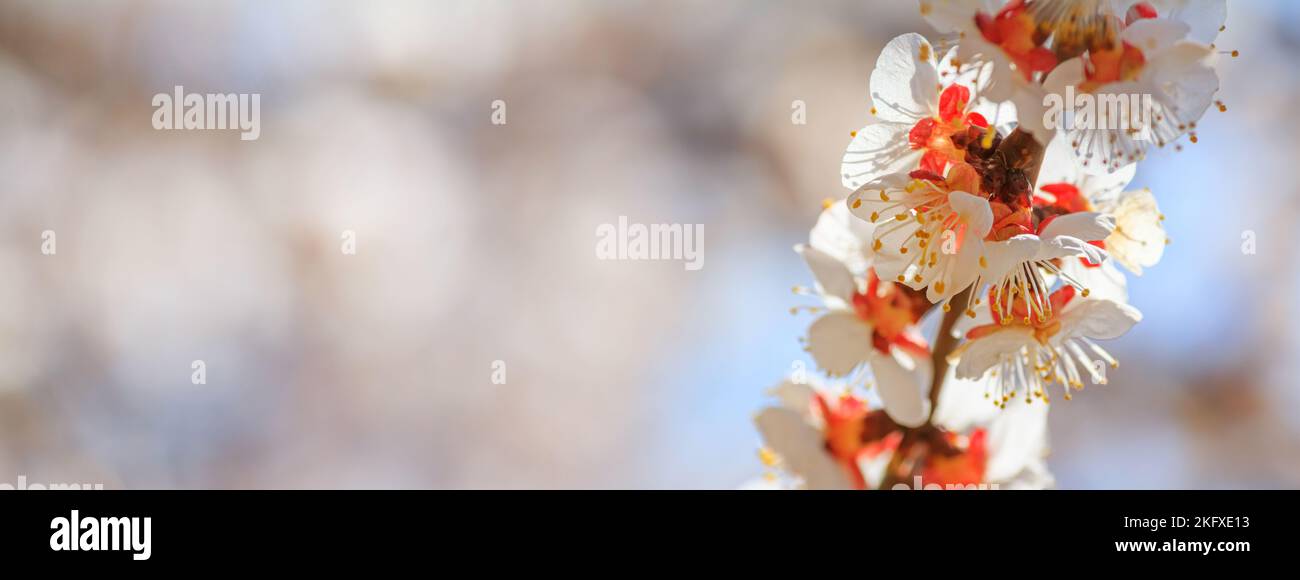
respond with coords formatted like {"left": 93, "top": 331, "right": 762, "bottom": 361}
{"left": 0, "top": 0, "right": 1300, "bottom": 488}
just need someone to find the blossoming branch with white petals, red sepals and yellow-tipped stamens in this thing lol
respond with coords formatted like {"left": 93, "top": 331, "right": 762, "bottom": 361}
{"left": 755, "top": 0, "right": 1226, "bottom": 489}
